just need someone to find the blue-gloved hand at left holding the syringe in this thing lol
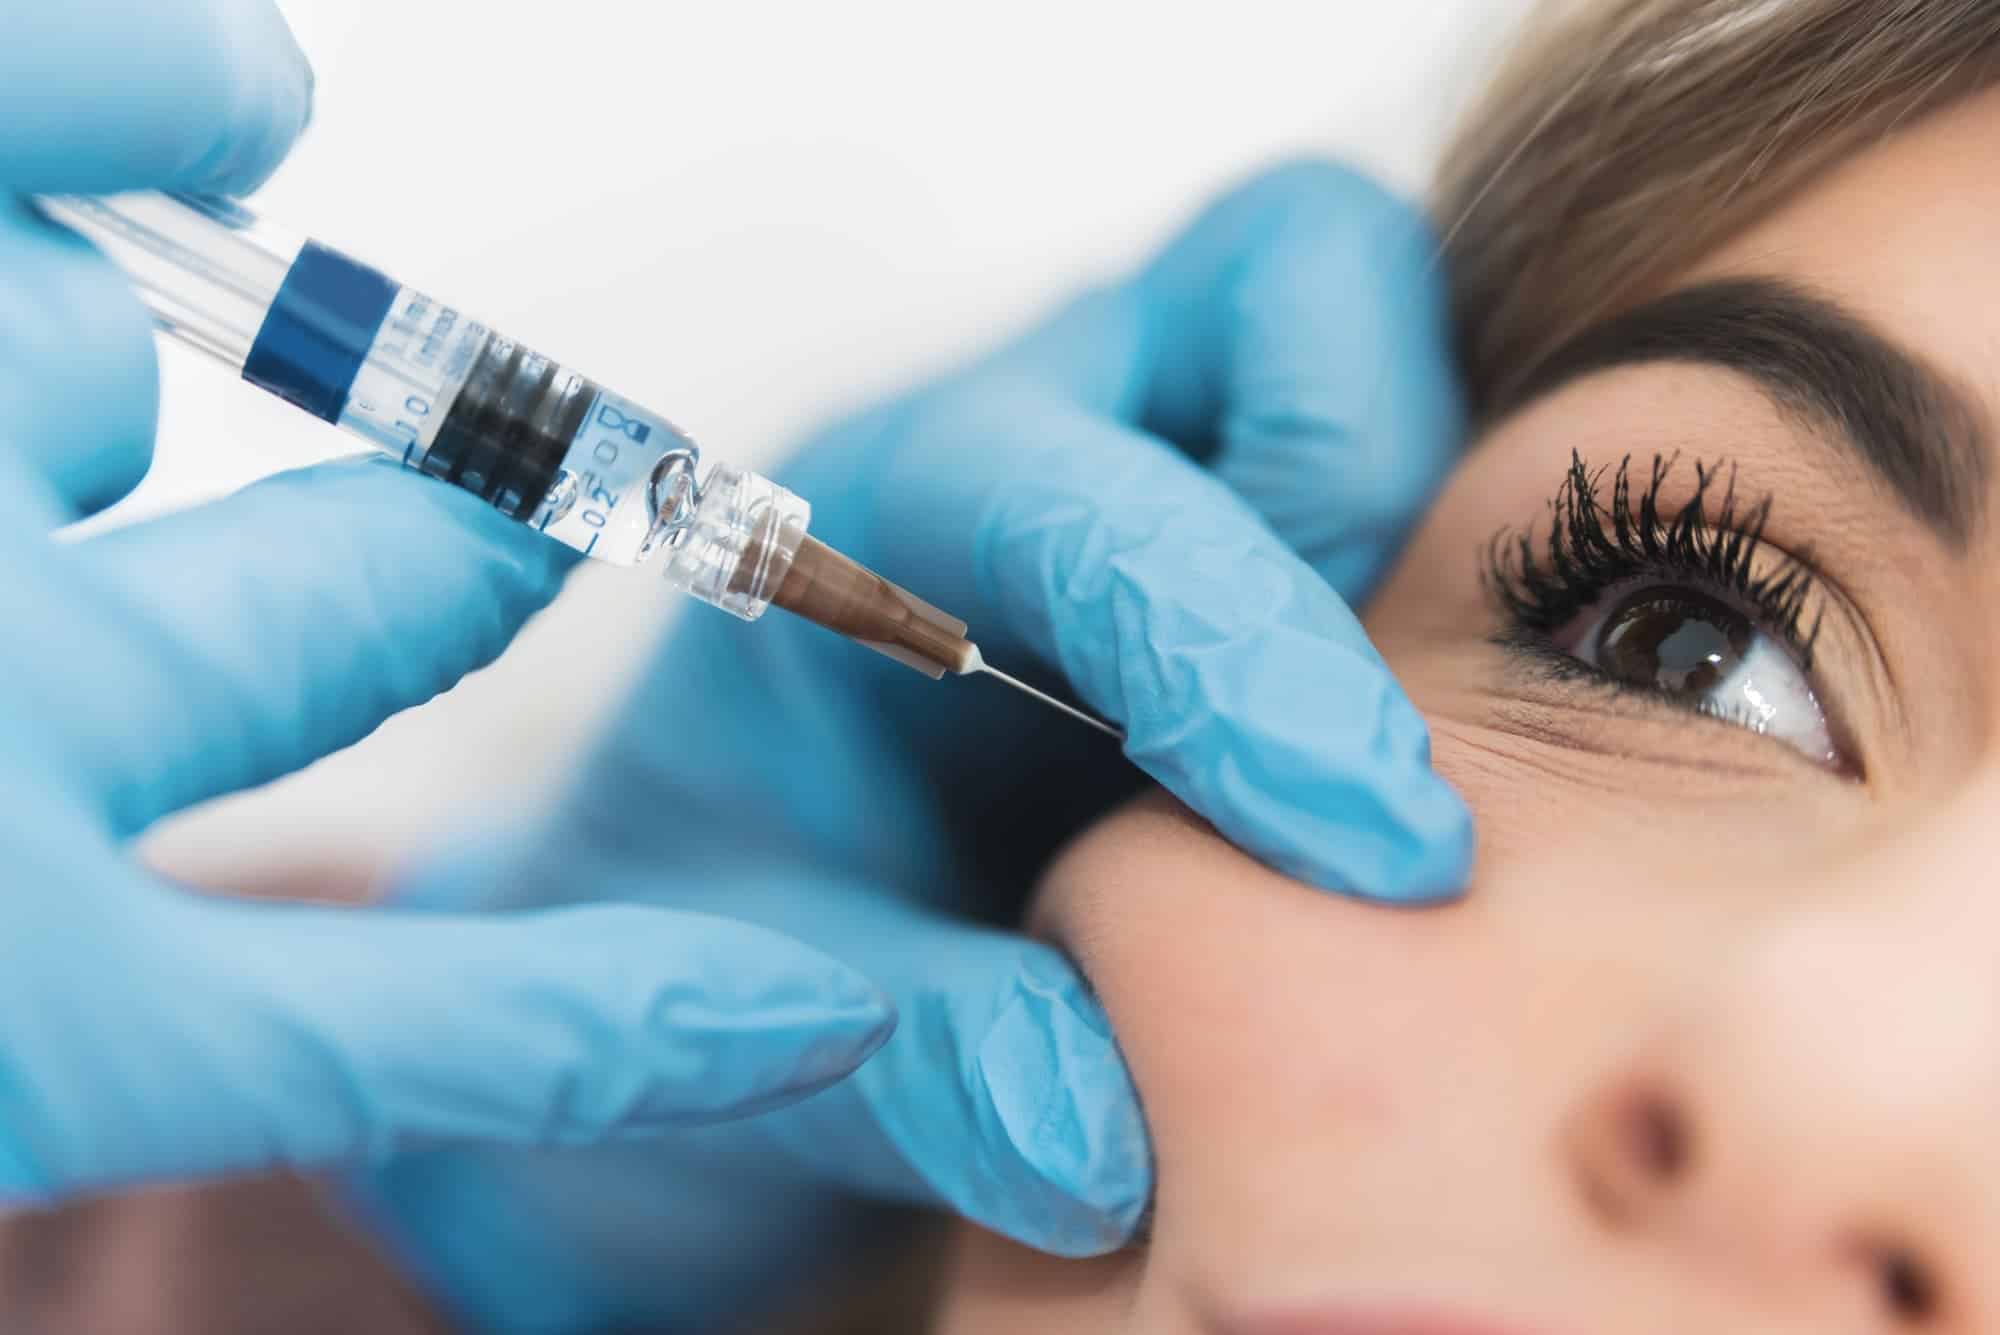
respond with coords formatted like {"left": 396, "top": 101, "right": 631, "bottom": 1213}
{"left": 0, "top": 0, "right": 888, "bottom": 1205}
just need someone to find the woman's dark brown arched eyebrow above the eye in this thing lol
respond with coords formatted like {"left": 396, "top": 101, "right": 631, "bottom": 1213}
{"left": 1514, "top": 278, "right": 1992, "bottom": 552}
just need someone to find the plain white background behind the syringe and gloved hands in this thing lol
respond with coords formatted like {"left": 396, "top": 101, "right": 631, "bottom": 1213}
{"left": 137, "top": 0, "right": 1526, "bottom": 877}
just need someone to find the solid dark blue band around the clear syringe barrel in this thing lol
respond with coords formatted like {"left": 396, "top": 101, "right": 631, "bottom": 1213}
{"left": 244, "top": 242, "right": 398, "bottom": 424}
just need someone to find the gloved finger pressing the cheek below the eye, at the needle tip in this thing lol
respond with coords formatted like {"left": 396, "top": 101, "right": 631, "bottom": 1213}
{"left": 828, "top": 391, "right": 1472, "bottom": 901}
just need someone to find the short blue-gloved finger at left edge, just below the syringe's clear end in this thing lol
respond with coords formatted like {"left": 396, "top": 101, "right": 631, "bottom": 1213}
{"left": 0, "top": 200, "right": 160, "bottom": 530}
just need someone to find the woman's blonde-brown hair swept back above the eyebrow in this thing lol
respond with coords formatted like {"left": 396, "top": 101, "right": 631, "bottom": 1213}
{"left": 1436, "top": 0, "right": 2000, "bottom": 420}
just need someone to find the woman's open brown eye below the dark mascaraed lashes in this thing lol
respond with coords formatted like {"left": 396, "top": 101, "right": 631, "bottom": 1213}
{"left": 1556, "top": 584, "right": 1840, "bottom": 765}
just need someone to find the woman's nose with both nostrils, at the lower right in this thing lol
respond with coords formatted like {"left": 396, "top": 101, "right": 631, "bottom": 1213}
{"left": 1562, "top": 903, "right": 2000, "bottom": 1333}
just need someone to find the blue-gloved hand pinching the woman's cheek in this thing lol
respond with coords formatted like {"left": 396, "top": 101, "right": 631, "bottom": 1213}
{"left": 362, "top": 166, "right": 1470, "bottom": 1331}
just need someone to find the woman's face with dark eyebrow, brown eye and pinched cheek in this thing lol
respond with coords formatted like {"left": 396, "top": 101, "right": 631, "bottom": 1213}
{"left": 942, "top": 94, "right": 2000, "bottom": 1335}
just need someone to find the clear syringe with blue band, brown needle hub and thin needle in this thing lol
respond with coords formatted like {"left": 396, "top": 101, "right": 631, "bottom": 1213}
{"left": 40, "top": 192, "right": 1120, "bottom": 737}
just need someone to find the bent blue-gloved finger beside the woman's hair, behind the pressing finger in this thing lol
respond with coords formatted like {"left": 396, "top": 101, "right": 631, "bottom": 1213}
{"left": 998, "top": 162, "right": 1464, "bottom": 600}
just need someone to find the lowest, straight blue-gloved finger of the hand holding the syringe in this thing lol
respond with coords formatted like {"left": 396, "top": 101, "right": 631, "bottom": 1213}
{"left": 0, "top": 875, "right": 892, "bottom": 1199}
